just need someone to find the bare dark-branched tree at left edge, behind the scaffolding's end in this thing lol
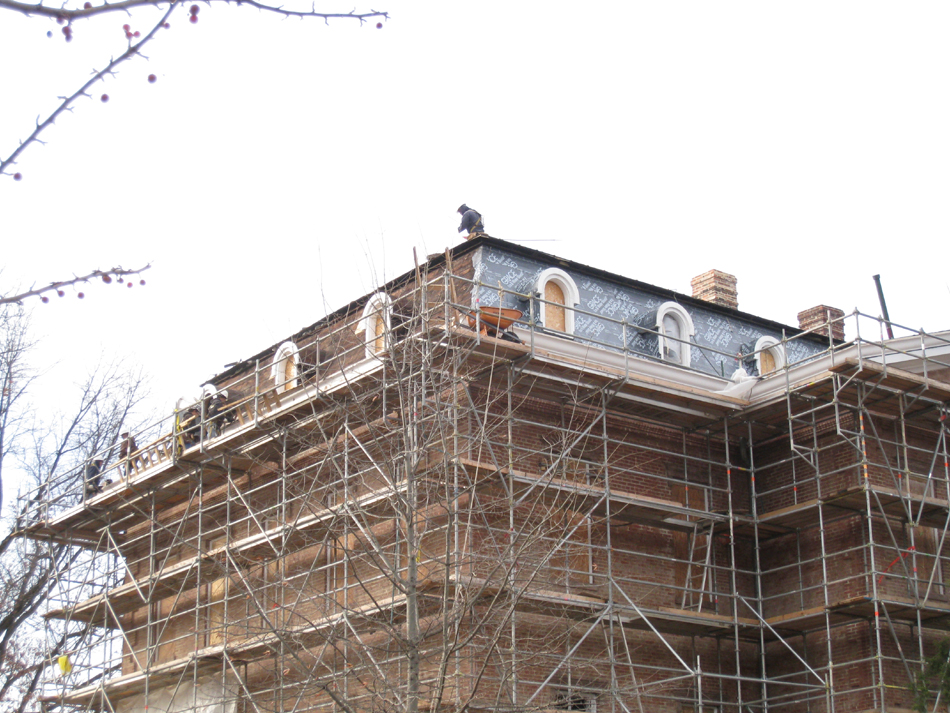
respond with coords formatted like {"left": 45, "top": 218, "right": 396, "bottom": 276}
{"left": 0, "top": 303, "right": 147, "bottom": 713}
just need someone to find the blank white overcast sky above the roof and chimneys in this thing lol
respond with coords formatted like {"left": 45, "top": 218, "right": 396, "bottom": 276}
{"left": 0, "top": 0, "right": 950, "bottom": 444}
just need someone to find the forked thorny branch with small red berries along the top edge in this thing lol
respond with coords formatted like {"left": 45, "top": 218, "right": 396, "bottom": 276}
{"left": 0, "top": 0, "right": 389, "bottom": 181}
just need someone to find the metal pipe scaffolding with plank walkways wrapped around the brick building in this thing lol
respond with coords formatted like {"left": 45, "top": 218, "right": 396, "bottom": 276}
{"left": 19, "top": 246, "right": 950, "bottom": 713}
